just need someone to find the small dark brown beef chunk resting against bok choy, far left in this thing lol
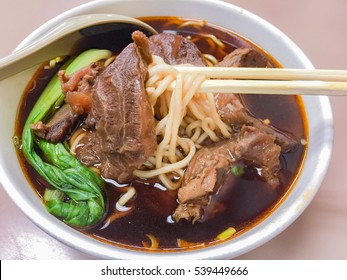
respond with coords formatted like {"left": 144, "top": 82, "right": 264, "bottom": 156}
{"left": 31, "top": 104, "right": 80, "bottom": 143}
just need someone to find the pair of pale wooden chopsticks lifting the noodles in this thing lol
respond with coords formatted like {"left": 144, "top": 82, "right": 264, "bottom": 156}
{"left": 174, "top": 66, "right": 347, "bottom": 96}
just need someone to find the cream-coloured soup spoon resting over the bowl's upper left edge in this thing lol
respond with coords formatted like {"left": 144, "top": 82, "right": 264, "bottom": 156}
{"left": 0, "top": 14, "right": 157, "bottom": 81}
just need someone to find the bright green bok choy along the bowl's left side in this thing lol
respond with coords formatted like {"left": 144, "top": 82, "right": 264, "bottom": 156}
{"left": 22, "top": 49, "right": 112, "bottom": 227}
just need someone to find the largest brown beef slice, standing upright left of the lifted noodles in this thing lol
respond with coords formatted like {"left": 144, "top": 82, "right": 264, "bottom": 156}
{"left": 76, "top": 31, "right": 157, "bottom": 182}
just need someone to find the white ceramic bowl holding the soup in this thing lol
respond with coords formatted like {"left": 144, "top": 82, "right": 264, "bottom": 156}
{"left": 0, "top": 0, "right": 333, "bottom": 259}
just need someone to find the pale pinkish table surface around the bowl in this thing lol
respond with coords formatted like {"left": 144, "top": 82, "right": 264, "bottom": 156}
{"left": 0, "top": 0, "right": 347, "bottom": 260}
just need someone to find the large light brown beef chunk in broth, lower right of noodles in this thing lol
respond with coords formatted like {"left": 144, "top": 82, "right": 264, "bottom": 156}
{"left": 173, "top": 126, "right": 281, "bottom": 222}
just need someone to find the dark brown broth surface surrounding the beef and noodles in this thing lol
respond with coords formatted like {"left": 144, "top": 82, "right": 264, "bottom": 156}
{"left": 16, "top": 17, "right": 306, "bottom": 250}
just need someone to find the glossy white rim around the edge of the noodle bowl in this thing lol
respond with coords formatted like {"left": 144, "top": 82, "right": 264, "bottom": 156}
{"left": 0, "top": 0, "right": 333, "bottom": 259}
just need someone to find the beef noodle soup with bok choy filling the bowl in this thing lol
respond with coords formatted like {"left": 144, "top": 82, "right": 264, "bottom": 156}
{"left": 16, "top": 17, "right": 307, "bottom": 250}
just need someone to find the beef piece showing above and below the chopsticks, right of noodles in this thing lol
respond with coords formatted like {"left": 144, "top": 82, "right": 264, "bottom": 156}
{"left": 214, "top": 48, "right": 298, "bottom": 152}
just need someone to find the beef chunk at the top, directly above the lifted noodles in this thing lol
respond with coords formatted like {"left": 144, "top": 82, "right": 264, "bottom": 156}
{"left": 149, "top": 33, "right": 206, "bottom": 66}
